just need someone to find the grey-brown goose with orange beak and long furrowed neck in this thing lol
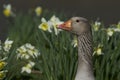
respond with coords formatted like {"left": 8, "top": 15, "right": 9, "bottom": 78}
{"left": 57, "top": 17, "right": 95, "bottom": 80}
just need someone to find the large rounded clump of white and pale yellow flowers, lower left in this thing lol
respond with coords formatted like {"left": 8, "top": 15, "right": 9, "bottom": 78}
{"left": 16, "top": 43, "right": 40, "bottom": 59}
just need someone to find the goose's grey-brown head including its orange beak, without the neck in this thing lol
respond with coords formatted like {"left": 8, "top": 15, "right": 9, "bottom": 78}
{"left": 58, "top": 17, "right": 91, "bottom": 35}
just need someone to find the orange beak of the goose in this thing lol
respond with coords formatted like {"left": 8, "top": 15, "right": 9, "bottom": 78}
{"left": 57, "top": 20, "right": 72, "bottom": 31}
